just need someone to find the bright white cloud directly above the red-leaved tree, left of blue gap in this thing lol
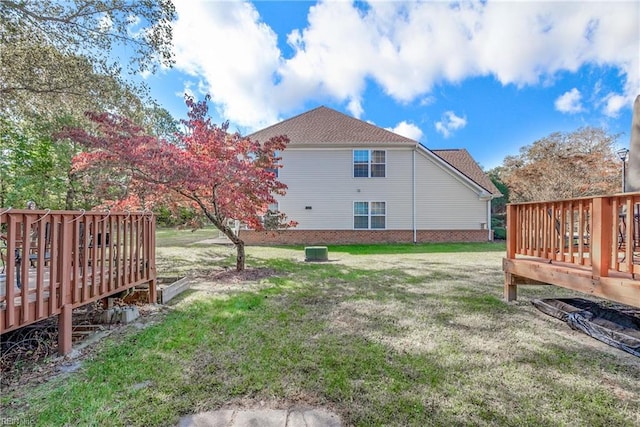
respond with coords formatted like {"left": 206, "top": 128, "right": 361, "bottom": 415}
{"left": 174, "top": 1, "right": 281, "bottom": 128}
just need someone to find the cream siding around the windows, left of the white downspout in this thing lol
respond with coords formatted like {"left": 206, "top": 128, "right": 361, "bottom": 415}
{"left": 278, "top": 147, "right": 412, "bottom": 230}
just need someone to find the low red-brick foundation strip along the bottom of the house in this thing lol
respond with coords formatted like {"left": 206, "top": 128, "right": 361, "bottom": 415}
{"left": 240, "top": 230, "right": 488, "bottom": 245}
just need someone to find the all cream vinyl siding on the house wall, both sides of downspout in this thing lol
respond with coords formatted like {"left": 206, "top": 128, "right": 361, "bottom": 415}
{"left": 278, "top": 147, "right": 487, "bottom": 230}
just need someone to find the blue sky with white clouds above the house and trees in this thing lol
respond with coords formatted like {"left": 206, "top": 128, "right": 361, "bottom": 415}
{"left": 146, "top": 0, "right": 640, "bottom": 169}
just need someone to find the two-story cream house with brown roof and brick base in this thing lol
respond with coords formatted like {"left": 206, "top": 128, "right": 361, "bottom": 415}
{"left": 240, "top": 107, "right": 501, "bottom": 244}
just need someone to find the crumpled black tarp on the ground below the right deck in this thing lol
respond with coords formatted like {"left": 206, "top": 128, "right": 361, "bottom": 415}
{"left": 532, "top": 298, "right": 640, "bottom": 357}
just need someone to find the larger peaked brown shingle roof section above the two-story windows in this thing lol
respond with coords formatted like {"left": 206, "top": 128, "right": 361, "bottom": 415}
{"left": 248, "top": 106, "right": 417, "bottom": 145}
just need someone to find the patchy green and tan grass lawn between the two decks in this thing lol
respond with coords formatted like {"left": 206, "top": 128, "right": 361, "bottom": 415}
{"left": 1, "top": 230, "right": 640, "bottom": 426}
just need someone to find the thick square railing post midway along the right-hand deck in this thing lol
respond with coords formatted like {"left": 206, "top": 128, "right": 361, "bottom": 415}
{"left": 591, "top": 197, "right": 613, "bottom": 278}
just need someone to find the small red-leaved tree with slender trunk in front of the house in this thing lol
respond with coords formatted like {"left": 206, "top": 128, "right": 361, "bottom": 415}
{"left": 61, "top": 97, "right": 296, "bottom": 271}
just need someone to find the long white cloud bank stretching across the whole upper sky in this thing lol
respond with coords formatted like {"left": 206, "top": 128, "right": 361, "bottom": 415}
{"left": 174, "top": 0, "right": 640, "bottom": 129}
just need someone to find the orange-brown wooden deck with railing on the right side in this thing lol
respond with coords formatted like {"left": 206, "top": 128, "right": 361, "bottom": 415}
{"left": 503, "top": 193, "right": 640, "bottom": 307}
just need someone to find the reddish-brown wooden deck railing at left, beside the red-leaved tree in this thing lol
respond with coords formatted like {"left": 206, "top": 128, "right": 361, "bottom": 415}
{"left": 0, "top": 208, "right": 156, "bottom": 354}
